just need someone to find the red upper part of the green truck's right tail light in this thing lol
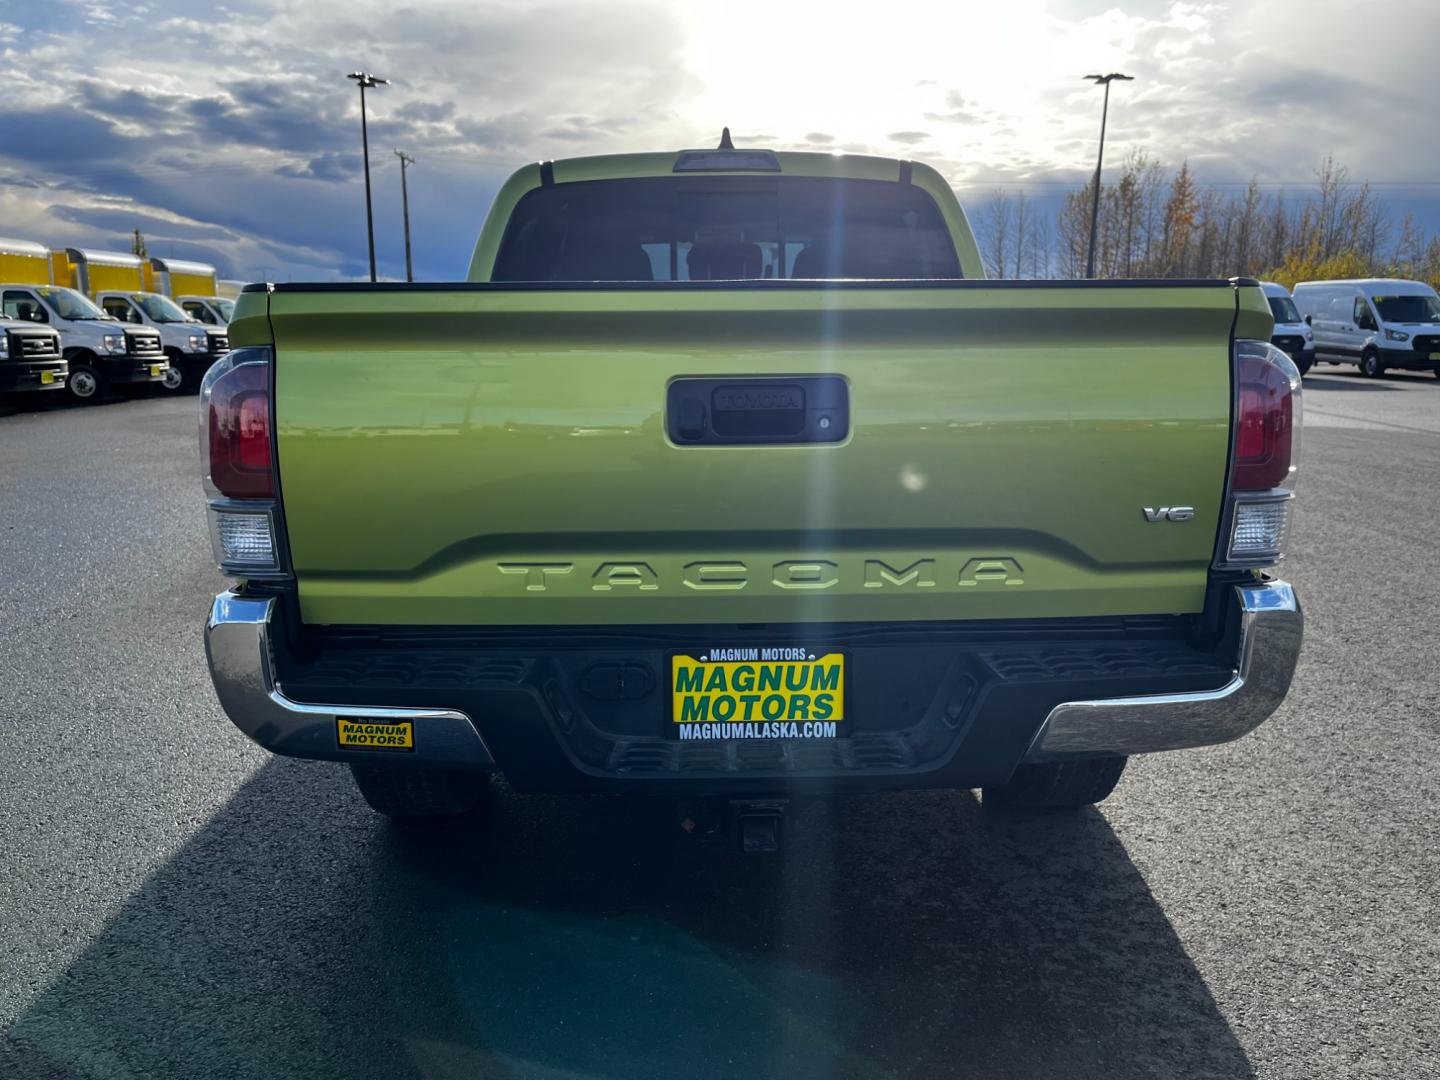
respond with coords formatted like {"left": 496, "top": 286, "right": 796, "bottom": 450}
{"left": 1231, "top": 341, "right": 1299, "bottom": 491}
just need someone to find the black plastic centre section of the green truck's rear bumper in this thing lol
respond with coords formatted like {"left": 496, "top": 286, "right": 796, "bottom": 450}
{"left": 264, "top": 619, "right": 1233, "bottom": 795}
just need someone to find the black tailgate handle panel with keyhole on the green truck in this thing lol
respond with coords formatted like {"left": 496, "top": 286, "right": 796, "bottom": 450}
{"left": 665, "top": 374, "right": 850, "bottom": 446}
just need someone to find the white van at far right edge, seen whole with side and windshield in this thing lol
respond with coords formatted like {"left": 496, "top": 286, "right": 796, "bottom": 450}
{"left": 1295, "top": 278, "right": 1440, "bottom": 379}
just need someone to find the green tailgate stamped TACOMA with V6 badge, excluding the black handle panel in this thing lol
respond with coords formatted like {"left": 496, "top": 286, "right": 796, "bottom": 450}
{"left": 269, "top": 281, "right": 1237, "bottom": 625}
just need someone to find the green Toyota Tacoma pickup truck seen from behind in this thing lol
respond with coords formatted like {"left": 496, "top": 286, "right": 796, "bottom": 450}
{"left": 200, "top": 148, "right": 1302, "bottom": 835}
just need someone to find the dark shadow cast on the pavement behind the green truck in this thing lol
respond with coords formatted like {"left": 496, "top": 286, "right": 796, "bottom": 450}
{"left": 0, "top": 760, "right": 1253, "bottom": 1080}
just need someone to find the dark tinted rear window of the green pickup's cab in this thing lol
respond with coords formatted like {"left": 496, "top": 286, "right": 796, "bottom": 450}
{"left": 491, "top": 176, "right": 960, "bottom": 281}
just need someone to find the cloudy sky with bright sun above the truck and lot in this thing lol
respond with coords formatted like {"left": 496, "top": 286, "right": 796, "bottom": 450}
{"left": 0, "top": 0, "right": 1440, "bottom": 281}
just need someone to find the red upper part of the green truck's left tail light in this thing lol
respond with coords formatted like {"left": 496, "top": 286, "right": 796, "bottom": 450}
{"left": 202, "top": 350, "right": 275, "bottom": 498}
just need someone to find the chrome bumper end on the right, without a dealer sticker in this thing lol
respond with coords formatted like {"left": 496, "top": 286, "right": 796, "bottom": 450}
{"left": 1025, "top": 582, "right": 1305, "bottom": 762}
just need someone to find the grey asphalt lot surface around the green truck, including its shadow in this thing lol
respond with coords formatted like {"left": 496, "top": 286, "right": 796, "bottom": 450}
{"left": 0, "top": 367, "right": 1440, "bottom": 1080}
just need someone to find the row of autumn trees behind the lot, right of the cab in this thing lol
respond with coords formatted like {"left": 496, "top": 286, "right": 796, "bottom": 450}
{"left": 978, "top": 153, "right": 1440, "bottom": 288}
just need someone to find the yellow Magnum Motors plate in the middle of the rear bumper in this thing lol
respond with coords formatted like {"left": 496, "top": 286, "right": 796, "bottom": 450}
{"left": 670, "top": 645, "right": 845, "bottom": 740}
